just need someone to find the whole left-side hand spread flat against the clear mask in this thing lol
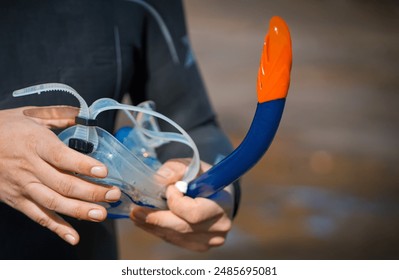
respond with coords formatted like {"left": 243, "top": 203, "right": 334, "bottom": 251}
{"left": 0, "top": 106, "right": 120, "bottom": 245}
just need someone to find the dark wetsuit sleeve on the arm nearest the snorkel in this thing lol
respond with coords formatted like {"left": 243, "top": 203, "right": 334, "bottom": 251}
{"left": 132, "top": 0, "right": 240, "bottom": 217}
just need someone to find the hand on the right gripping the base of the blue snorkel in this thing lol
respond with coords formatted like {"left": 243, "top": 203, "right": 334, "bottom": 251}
{"left": 130, "top": 160, "right": 233, "bottom": 252}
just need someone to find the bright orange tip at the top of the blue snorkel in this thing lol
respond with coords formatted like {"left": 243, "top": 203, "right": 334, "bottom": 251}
{"left": 257, "top": 16, "right": 292, "bottom": 103}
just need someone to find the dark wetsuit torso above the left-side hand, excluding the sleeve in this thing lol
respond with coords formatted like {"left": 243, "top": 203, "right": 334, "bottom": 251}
{"left": 0, "top": 0, "right": 146, "bottom": 130}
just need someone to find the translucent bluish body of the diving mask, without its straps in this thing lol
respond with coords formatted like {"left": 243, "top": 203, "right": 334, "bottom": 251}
{"left": 58, "top": 127, "right": 167, "bottom": 218}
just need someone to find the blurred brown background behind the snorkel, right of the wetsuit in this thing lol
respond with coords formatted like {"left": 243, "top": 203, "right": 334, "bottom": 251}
{"left": 118, "top": 0, "right": 399, "bottom": 259}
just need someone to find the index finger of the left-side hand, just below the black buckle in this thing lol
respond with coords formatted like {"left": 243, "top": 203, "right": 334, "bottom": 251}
{"left": 36, "top": 135, "right": 108, "bottom": 178}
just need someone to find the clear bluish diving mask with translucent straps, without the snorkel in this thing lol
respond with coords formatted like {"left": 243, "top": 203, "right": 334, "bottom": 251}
{"left": 13, "top": 83, "right": 200, "bottom": 218}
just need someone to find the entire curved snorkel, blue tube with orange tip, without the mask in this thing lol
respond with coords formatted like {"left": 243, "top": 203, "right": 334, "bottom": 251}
{"left": 186, "top": 17, "right": 292, "bottom": 198}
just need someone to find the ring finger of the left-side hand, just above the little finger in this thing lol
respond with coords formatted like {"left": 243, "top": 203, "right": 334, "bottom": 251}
{"left": 26, "top": 183, "right": 107, "bottom": 222}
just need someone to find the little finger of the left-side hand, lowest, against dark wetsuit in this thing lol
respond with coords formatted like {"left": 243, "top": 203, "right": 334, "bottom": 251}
{"left": 17, "top": 197, "right": 79, "bottom": 245}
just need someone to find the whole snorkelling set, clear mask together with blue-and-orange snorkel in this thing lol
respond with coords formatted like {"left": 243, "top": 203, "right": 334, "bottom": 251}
{"left": 13, "top": 17, "right": 292, "bottom": 218}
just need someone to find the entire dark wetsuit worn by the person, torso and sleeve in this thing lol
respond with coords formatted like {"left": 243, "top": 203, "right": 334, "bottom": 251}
{"left": 0, "top": 0, "right": 238, "bottom": 259}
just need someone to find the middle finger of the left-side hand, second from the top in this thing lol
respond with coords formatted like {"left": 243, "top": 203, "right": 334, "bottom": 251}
{"left": 36, "top": 163, "right": 121, "bottom": 202}
